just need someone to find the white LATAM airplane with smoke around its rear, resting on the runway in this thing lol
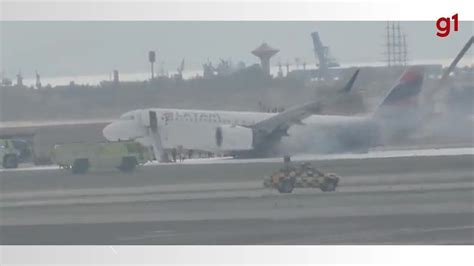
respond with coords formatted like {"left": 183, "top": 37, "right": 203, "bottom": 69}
{"left": 103, "top": 66, "right": 424, "bottom": 161}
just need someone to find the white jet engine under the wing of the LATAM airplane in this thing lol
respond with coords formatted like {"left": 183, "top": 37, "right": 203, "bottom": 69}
{"left": 215, "top": 125, "right": 253, "bottom": 151}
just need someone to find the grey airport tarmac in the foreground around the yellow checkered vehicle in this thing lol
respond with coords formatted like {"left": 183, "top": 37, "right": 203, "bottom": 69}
{"left": 0, "top": 149, "right": 474, "bottom": 245}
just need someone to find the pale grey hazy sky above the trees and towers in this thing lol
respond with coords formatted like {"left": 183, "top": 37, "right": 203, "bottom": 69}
{"left": 0, "top": 21, "right": 474, "bottom": 78}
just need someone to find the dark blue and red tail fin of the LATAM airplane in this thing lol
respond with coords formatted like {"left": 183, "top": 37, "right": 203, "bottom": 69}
{"left": 375, "top": 66, "right": 424, "bottom": 117}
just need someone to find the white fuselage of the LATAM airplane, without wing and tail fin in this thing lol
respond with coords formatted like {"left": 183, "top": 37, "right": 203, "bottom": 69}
{"left": 103, "top": 109, "right": 373, "bottom": 155}
